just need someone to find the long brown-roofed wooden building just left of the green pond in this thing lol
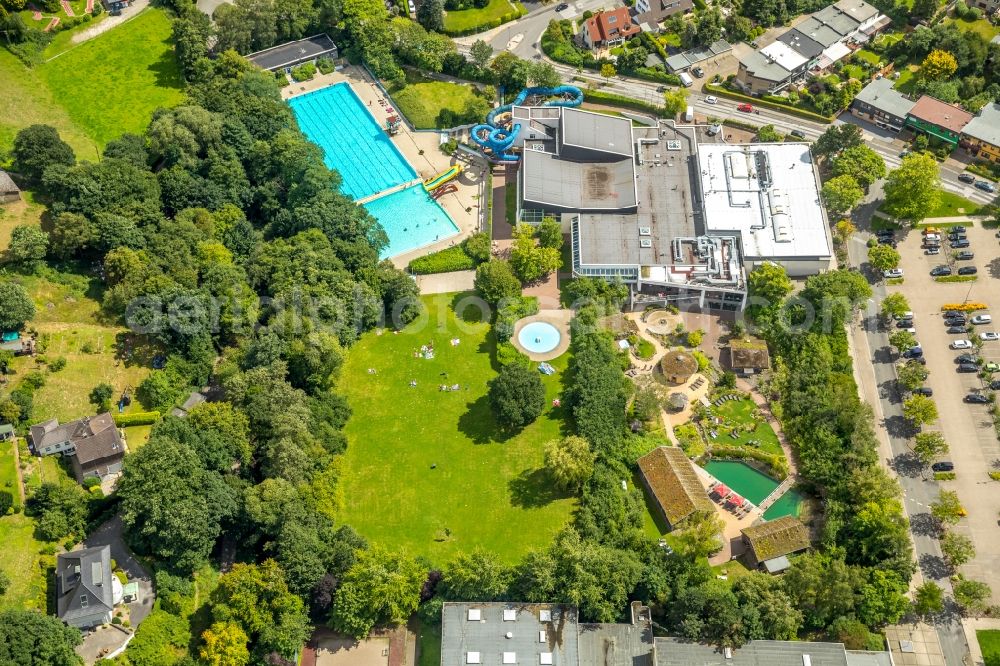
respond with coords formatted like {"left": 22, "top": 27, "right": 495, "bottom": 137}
{"left": 639, "top": 446, "right": 715, "bottom": 529}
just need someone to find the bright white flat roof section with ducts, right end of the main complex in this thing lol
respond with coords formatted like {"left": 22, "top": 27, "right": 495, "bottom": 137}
{"left": 698, "top": 143, "right": 833, "bottom": 276}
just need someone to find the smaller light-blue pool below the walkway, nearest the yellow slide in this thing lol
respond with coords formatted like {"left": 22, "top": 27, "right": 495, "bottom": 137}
{"left": 363, "top": 185, "right": 458, "bottom": 259}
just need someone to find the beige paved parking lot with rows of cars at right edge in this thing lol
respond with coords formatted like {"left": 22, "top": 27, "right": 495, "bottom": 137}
{"left": 888, "top": 223, "right": 1000, "bottom": 600}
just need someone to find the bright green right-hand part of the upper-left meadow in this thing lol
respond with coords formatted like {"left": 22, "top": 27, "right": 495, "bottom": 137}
{"left": 40, "top": 9, "right": 183, "bottom": 146}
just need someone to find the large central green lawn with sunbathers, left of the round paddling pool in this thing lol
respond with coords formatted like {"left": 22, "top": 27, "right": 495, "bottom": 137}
{"left": 340, "top": 295, "right": 576, "bottom": 566}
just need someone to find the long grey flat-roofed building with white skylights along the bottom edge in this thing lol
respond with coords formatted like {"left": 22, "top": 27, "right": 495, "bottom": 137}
{"left": 440, "top": 601, "right": 893, "bottom": 666}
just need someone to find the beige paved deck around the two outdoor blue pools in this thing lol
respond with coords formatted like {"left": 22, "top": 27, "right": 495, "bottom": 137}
{"left": 281, "top": 65, "right": 487, "bottom": 268}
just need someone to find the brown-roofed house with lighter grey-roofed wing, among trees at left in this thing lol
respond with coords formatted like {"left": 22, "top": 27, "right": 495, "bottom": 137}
{"left": 30, "top": 412, "right": 125, "bottom": 483}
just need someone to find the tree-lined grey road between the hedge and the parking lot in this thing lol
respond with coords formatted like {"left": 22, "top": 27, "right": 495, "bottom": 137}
{"left": 848, "top": 237, "right": 969, "bottom": 666}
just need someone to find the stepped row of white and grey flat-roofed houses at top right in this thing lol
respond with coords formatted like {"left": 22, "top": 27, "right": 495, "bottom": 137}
{"left": 735, "top": 0, "right": 892, "bottom": 95}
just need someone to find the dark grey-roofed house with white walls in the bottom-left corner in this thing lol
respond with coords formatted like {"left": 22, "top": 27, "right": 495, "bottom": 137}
{"left": 56, "top": 545, "right": 118, "bottom": 629}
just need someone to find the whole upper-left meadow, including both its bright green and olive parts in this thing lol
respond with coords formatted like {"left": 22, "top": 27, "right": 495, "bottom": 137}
{"left": 0, "top": 9, "right": 183, "bottom": 160}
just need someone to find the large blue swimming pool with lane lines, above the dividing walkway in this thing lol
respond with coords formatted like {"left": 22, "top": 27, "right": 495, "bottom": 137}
{"left": 288, "top": 83, "right": 417, "bottom": 200}
